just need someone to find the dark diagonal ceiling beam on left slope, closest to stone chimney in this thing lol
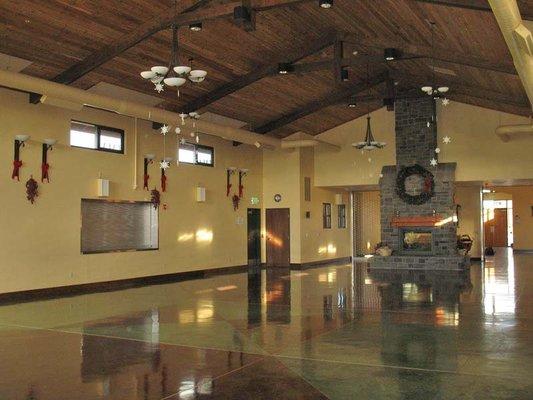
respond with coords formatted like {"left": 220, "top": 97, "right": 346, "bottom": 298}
{"left": 254, "top": 72, "right": 388, "bottom": 134}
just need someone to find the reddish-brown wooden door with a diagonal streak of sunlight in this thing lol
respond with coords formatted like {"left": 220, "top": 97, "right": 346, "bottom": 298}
{"left": 266, "top": 208, "right": 291, "bottom": 267}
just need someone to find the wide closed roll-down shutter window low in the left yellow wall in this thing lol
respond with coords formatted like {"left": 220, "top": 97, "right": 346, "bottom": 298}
{"left": 81, "top": 199, "right": 159, "bottom": 254}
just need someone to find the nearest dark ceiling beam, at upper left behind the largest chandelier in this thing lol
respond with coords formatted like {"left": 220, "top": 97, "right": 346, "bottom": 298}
{"left": 52, "top": 0, "right": 307, "bottom": 84}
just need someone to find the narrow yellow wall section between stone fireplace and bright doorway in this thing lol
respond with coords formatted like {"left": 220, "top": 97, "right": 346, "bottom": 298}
{"left": 455, "top": 186, "right": 482, "bottom": 258}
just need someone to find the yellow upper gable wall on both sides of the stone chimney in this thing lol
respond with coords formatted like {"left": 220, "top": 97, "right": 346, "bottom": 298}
{"left": 315, "top": 101, "right": 533, "bottom": 186}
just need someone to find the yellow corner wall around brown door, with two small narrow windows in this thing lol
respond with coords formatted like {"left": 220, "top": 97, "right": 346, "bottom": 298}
{"left": 262, "top": 148, "right": 351, "bottom": 264}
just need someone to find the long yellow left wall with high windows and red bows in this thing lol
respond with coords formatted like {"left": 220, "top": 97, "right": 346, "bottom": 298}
{"left": 0, "top": 89, "right": 263, "bottom": 293}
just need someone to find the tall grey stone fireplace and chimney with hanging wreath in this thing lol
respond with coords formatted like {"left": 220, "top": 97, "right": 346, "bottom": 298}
{"left": 370, "top": 97, "right": 468, "bottom": 270}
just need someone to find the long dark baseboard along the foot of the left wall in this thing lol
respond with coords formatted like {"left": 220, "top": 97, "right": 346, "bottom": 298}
{"left": 0, "top": 265, "right": 248, "bottom": 305}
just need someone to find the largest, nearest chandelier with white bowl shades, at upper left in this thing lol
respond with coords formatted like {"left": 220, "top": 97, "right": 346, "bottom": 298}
{"left": 141, "top": 25, "right": 207, "bottom": 96}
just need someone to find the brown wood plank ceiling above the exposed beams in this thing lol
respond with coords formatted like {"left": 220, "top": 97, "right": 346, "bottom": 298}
{"left": 0, "top": 0, "right": 533, "bottom": 137}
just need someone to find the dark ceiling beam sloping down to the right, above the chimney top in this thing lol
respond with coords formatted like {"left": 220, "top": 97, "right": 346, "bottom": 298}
{"left": 340, "top": 33, "right": 517, "bottom": 75}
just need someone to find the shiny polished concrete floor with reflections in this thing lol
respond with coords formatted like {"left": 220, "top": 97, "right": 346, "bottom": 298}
{"left": 0, "top": 249, "right": 533, "bottom": 400}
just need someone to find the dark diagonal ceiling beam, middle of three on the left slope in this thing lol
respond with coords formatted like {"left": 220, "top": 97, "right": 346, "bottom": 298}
{"left": 184, "top": 33, "right": 335, "bottom": 112}
